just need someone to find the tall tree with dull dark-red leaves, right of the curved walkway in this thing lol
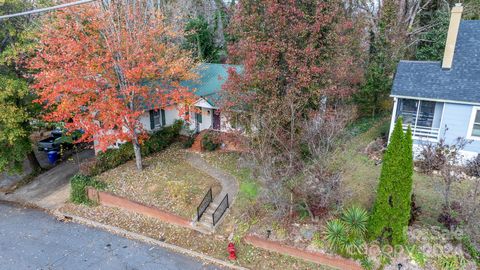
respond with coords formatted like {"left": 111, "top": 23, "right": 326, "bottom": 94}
{"left": 223, "top": 0, "right": 363, "bottom": 218}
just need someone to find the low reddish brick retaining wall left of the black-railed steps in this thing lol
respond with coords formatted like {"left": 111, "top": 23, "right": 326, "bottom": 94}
{"left": 87, "top": 187, "right": 194, "bottom": 229}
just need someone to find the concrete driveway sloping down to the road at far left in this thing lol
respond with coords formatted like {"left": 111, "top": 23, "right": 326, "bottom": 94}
{"left": 0, "top": 150, "right": 95, "bottom": 210}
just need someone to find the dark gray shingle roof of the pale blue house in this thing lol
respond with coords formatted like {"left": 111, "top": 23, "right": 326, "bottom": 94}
{"left": 392, "top": 20, "right": 480, "bottom": 103}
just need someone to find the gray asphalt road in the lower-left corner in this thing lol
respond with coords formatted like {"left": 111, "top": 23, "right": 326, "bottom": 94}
{"left": 0, "top": 201, "right": 220, "bottom": 270}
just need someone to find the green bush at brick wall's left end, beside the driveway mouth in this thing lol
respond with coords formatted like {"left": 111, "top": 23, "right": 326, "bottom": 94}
{"left": 70, "top": 174, "right": 107, "bottom": 204}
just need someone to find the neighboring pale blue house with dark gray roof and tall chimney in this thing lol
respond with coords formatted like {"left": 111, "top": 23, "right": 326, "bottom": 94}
{"left": 390, "top": 4, "right": 480, "bottom": 158}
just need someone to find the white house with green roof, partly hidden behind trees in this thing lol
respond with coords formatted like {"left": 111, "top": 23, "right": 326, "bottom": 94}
{"left": 140, "top": 63, "right": 241, "bottom": 135}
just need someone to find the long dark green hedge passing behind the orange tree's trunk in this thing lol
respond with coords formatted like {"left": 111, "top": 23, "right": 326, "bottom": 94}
{"left": 91, "top": 120, "right": 183, "bottom": 175}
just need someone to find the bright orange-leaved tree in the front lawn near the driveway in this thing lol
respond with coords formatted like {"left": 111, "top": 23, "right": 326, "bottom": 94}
{"left": 31, "top": 0, "right": 196, "bottom": 170}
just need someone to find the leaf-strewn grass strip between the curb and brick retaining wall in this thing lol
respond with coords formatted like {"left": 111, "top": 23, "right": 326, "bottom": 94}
{"left": 61, "top": 203, "right": 333, "bottom": 270}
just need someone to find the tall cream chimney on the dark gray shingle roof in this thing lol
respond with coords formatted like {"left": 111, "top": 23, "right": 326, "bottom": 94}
{"left": 442, "top": 3, "right": 463, "bottom": 69}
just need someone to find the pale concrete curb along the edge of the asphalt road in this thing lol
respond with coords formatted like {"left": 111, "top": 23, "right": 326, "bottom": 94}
{"left": 52, "top": 210, "right": 248, "bottom": 270}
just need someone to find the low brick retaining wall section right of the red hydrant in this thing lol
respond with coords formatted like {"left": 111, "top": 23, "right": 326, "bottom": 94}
{"left": 244, "top": 235, "right": 362, "bottom": 270}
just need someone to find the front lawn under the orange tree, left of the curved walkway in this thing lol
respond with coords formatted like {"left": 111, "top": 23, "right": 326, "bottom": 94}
{"left": 97, "top": 143, "right": 221, "bottom": 218}
